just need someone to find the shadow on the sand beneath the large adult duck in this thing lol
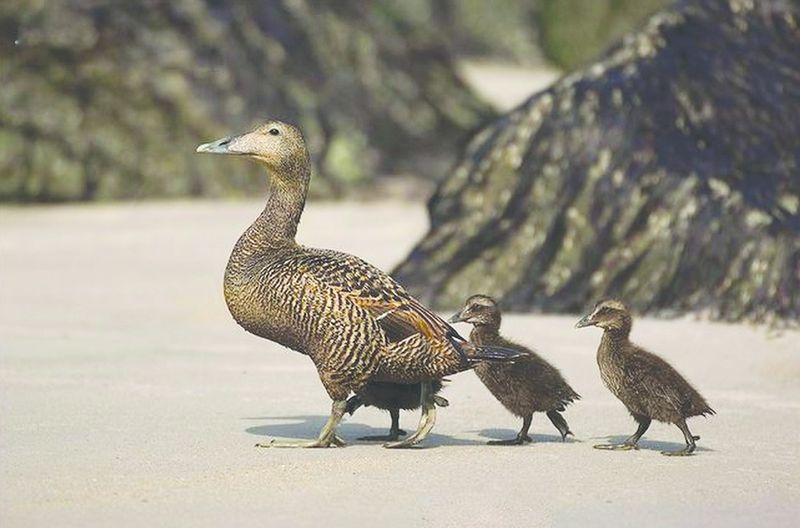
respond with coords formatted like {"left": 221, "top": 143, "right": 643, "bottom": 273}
{"left": 244, "top": 415, "right": 484, "bottom": 448}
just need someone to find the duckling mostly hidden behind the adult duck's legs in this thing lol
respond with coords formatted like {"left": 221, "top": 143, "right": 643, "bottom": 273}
{"left": 347, "top": 380, "right": 450, "bottom": 442}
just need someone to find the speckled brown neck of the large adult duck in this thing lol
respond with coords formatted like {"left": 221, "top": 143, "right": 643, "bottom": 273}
{"left": 239, "top": 166, "right": 310, "bottom": 251}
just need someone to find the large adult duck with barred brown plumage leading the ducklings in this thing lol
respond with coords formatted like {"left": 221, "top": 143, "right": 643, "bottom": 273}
{"left": 197, "top": 120, "right": 517, "bottom": 447}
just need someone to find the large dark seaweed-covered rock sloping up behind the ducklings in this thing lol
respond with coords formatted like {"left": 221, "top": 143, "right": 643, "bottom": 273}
{"left": 396, "top": 0, "right": 800, "bottom": 321}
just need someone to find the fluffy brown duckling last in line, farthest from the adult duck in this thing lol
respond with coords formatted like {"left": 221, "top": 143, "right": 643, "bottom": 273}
{"left": 575, "top": 299, "right": 716, "bottom": 456}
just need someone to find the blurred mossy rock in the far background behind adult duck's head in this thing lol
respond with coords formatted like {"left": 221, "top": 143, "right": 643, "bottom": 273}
{"left": 0, "top": 0, "right": 664, "bottom": 202}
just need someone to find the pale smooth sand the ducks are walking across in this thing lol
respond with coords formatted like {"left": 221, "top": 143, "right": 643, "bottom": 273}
{"left": 0, "top": 202, "right": 800, "bottom": 528}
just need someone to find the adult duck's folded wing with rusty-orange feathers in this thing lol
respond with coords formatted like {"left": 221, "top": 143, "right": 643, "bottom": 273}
{"left": 307, "top": 251, "right": 466, "bottom": 348}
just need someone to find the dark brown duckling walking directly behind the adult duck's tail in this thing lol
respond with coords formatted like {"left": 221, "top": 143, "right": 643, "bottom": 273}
{"left": 450, "top": 295, "right": 580, "bottom": 445}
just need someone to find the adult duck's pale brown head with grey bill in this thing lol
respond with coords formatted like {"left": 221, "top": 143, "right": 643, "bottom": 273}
{"left": 197, "top": 120, "right": 308, "bottom": 173}
